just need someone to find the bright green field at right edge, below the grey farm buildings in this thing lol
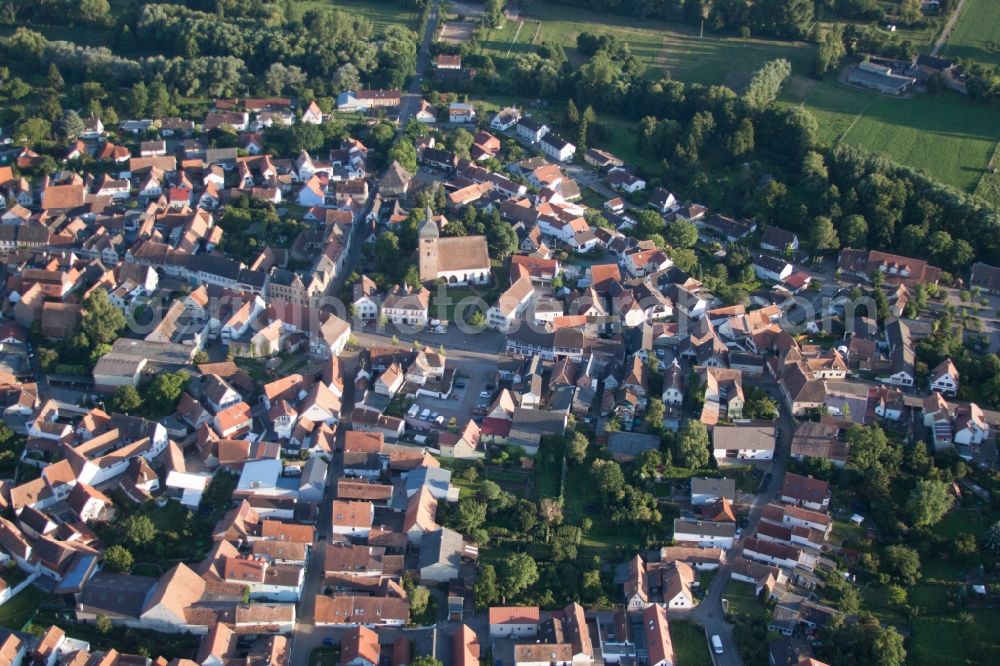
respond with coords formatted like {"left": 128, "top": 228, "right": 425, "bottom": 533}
{"left": 783, "top": 80, "right": 1000, "bottom": 192}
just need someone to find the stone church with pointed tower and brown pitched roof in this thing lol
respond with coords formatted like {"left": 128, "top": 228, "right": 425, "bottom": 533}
{"left": 419, "top": 206, "right": 490, "bottom": 284}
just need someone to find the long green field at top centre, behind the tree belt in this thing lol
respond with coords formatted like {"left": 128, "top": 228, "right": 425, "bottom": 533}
{"left": 483, "top": 2, "right": 814, "bottom": 90}
